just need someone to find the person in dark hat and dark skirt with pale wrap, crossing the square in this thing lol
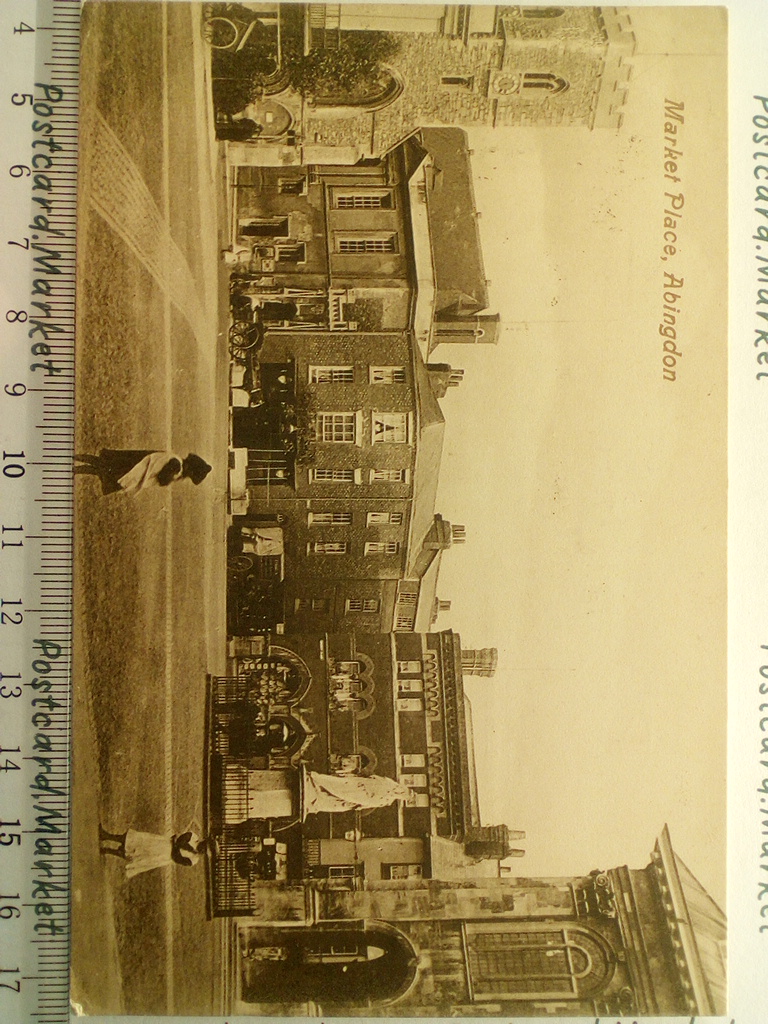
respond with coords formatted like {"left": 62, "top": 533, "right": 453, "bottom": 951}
{"left": 75, "top": 449, "right": 211, "bottom": 496}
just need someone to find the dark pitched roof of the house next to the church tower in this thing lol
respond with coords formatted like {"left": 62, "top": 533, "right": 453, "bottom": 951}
{"left": 420, "top": 128, "right": 489, "bottom": 317}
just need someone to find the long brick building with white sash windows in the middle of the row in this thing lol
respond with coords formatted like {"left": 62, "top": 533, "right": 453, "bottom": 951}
{"left": 227, "top": 331, "right": 464, "bottom": 636}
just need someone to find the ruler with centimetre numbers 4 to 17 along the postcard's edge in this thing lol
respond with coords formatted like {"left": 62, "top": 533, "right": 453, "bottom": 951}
{"left": 0, "top": 0, "right": 80, "bottom": 1024}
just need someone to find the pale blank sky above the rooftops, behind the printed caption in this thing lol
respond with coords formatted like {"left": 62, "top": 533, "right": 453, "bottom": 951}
{"left": 434, "top": 8, "right": 726, "bottom": 905}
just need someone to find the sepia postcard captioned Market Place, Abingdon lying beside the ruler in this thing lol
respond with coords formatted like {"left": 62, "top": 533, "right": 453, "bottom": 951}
{"left": 72, "top": 0, "right": 729, "bottom": 1020}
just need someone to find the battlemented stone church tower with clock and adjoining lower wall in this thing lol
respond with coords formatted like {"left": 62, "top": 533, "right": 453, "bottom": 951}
{"left": 224, "top": 3, "right": 635, "bottom": 166}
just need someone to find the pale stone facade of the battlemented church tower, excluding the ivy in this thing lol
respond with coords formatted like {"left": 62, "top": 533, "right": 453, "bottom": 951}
{"left": 228, "top": 4, "right": 634, "bottom": 163}
